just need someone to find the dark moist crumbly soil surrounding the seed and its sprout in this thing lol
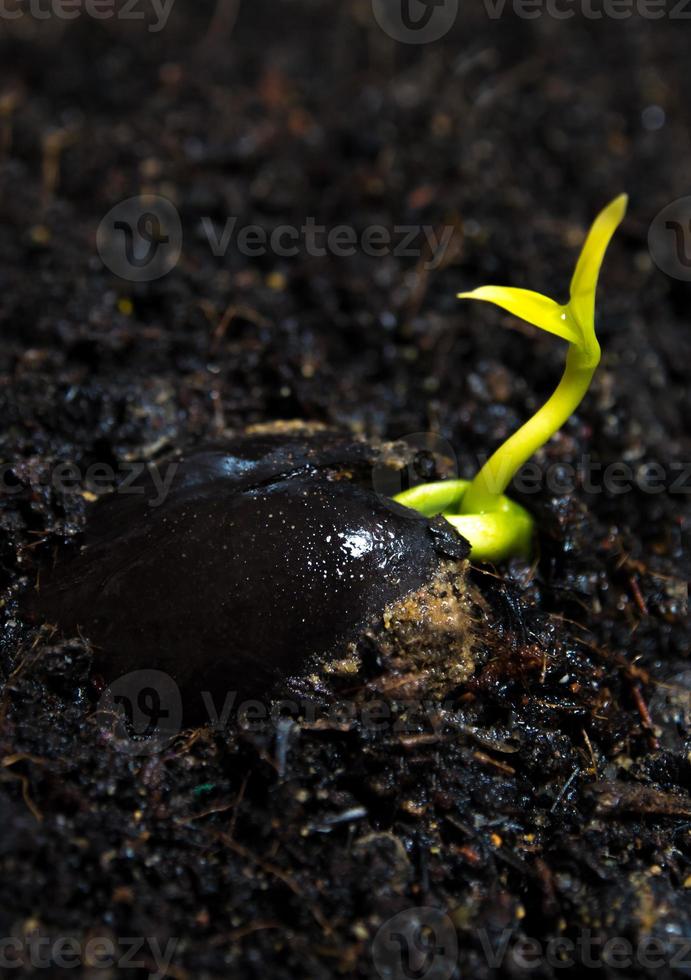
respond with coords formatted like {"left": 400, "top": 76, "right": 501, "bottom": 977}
{"left": 0, "top": 0, "right": 691, "bottom": 980}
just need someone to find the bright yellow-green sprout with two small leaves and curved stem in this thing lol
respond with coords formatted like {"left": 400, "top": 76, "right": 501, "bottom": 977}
{"left": 394, "top": 194, "right": 628, "bottom": 561}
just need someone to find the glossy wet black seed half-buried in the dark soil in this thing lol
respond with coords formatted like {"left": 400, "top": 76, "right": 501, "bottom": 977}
{"left": 25, "top": 435, "right": 468, "bottom": 718}
